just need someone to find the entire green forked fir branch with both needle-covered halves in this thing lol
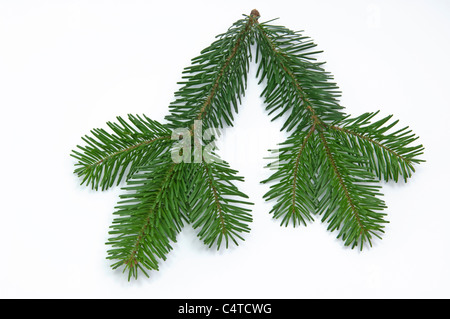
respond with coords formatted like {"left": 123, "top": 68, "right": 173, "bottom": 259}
{"left": 71, "top": 10, "right": 424, "bottom": 279}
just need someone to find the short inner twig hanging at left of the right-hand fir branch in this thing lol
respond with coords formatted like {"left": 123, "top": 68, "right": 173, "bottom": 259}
{"left": 262, "top": 125, "right": 317, "bottom": 227}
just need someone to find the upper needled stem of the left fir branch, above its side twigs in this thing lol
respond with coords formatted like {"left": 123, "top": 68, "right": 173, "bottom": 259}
{"left": 166, "top": 15, "right": 257, "bottom": 128}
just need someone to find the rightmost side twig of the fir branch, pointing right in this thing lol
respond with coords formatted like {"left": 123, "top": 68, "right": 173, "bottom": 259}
{"left": 330, "top": 112, "right": 424, "bottom": 182}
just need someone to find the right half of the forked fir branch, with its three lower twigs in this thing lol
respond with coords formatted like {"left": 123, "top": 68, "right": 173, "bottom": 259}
{"left": 255, "top": 16, "right": 423, "bottom": 249}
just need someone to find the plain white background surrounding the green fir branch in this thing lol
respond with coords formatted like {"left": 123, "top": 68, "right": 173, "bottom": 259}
{"left": 0, "top": 0, "right": 450, "bottom": 298}
